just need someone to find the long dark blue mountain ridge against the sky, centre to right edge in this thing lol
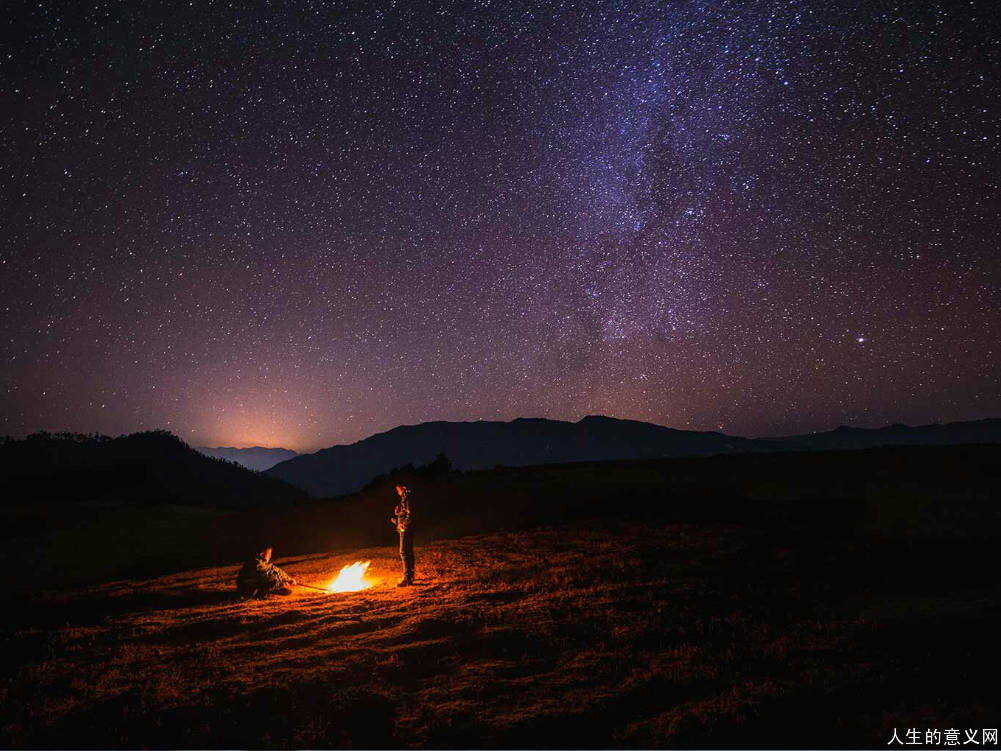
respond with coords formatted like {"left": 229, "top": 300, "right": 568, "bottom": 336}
{"left": 265, "top": 417, "right": 1001, "bottom": 498}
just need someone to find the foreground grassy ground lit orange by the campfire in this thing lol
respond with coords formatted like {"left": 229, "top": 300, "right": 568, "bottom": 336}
{"left": 0, "top": 522, "right": 1001, "bottom": 748}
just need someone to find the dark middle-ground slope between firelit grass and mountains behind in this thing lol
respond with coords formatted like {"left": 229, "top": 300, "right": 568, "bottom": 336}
{"left": 7, "top": 445, "right": 1001, "bottom": 599}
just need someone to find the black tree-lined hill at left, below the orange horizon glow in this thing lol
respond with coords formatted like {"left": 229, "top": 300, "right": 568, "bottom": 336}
{"left": 0, "top": 431, "right": 305, "bottom": 508}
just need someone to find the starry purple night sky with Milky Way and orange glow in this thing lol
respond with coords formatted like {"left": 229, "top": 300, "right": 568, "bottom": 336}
{"left": 0, "top": 0, "right": 1001, "bottom": 450}
